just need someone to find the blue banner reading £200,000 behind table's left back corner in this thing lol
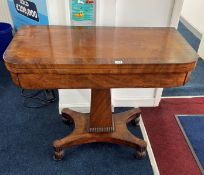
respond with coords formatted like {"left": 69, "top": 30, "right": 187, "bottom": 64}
{"left": 8, "top": 0, "right": 48, "bottom": 30}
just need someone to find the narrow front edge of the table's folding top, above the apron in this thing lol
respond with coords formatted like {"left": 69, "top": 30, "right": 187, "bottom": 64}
{"left": 5, "top": 62, "right": 196, "bottom": 75}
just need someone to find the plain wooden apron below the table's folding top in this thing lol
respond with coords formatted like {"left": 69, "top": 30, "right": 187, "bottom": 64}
{"left": 11, "top": 72, "right": 190, "bottom": 89}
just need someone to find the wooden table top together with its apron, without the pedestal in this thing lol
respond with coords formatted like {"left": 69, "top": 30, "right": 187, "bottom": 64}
{"left": 4, "top": 26, "right": 198, "bottom": 89}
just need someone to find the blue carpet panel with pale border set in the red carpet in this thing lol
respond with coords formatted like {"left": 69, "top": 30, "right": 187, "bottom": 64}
{"left": 177, "top": 115, "right": 204, "bottom": 174}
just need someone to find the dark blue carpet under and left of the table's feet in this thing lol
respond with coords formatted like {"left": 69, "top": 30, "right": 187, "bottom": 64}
{"left": 0, "top": 61, "right": 153, "bottom": 175}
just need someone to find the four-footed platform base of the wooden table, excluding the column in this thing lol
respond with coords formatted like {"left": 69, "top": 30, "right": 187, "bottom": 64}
{"left": 53, "top": 108, "right": 147, "bottom": 160}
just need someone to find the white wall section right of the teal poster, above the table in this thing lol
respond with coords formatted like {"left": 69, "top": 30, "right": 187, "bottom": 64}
{"left": 96, "top": 0, "right": 174, "bottom": 27}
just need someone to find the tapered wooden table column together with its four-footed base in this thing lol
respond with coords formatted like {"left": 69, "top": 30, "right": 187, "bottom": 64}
{"left": 53, "top": 89, "right": 147, "bottom": 160}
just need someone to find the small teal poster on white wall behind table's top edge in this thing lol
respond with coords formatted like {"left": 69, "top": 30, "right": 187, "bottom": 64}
{"left": 70, "top": 0, "right": 95, "bottom": 25}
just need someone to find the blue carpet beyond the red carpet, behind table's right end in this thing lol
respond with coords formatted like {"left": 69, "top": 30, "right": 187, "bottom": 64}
{"left": 162, "top": 23, "right": 204, "bottom": 96}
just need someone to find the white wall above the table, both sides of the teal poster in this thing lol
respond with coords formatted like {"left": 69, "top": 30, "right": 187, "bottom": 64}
{"left": 47, "top": 0, "right": 180, "bottom": 27}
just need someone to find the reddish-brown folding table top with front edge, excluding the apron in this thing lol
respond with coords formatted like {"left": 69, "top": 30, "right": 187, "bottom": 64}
{"left": 4, "top": 26, "right": 198, "bottom": 73}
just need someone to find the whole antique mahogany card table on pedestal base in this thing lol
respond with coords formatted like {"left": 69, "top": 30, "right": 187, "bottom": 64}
{"left": 4, "top": 26, "right": 198, "bottom": 160}
